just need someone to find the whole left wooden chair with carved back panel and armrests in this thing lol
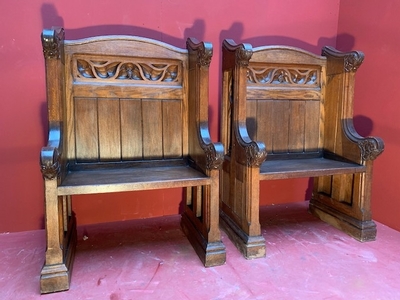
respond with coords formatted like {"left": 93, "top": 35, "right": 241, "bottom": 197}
{"left": 40, "top": 29, "right": 225, "bottom": 293}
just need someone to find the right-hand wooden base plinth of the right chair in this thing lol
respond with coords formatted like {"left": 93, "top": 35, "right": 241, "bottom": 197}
{"left": 309, "top": 200, "right": 376, "bottom": 242}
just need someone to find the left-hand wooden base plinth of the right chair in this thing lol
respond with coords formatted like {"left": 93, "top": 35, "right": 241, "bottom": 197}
{"left": 220, "top": 212, "right": 266, "bottom": 259}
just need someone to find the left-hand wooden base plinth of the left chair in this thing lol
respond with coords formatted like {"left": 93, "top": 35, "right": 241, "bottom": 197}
{"left": 40, "top": 215, "right": 77, "bottom": 294}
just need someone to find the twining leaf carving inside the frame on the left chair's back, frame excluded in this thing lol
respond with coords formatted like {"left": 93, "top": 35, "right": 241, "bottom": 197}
{"left": 76, "top": 59, "right": 178, "bottom": 82}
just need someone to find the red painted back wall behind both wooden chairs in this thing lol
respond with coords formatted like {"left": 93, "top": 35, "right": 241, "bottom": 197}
{"left": 0, "top": 0, "right": 340, "bottom": 233}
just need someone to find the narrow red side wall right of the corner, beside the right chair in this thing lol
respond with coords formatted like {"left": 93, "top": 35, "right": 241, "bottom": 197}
{"left": 337, "top": 0, "right": 400, "bottom": 231}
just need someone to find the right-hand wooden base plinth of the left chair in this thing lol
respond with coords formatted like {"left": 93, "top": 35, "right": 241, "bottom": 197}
{"left": 181, "top": 213, "right": 226, "bottom": 267}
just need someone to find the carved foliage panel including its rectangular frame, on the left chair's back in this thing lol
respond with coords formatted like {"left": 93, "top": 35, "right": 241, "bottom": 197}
{"left": 72, "top": 55, "right": 182, "bottom": 85}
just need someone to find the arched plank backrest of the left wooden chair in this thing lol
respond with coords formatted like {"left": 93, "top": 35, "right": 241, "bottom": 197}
{"left": 44, "top": 32, "right": 189, "bottom": 163}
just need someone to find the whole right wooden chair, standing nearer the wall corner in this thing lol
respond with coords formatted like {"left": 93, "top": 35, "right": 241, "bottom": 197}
{"left": 220, "top": 40, "right": 384, "bottom": 258}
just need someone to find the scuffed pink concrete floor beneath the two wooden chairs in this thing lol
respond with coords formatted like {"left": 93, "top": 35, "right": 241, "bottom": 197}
{"left": 0, "top": 202, "right": 400, "bottom": 300}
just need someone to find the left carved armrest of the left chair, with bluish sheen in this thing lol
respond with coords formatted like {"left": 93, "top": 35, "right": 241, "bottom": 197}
{"left": 40, "top": 124, "right": 61, "bottom": 179}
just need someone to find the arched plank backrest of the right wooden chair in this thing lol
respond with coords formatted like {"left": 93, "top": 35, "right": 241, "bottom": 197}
{"left": 246, "top": 46, "right": 326, "bottom": 159}
